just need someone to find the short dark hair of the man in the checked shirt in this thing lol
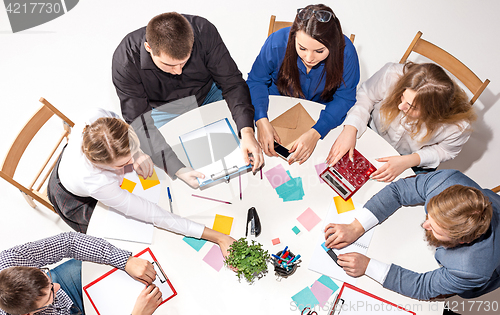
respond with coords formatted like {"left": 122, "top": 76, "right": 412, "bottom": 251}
{"left": 0, "top": 267, "right": 50, "bottom": 315}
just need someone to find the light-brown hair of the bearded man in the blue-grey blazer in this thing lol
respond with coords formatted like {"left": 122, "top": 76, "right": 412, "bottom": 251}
{"left": 427, "top": 185, "right": 493, "bottom": 243}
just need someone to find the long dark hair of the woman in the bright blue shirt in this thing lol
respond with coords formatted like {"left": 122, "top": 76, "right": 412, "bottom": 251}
{"left": 276, "top": 4, "right": 345, "bottom": 101}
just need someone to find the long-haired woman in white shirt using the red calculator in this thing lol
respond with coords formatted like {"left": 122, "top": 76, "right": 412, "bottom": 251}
{"left": 327, "top": 62, "right": 476, "bottom": 182}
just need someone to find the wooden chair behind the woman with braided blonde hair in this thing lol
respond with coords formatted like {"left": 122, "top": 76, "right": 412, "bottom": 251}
{"left": 0, "top": 97, "right": 75, "bottom": 212}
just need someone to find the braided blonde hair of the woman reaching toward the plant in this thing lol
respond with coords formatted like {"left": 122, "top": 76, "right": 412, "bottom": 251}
{"left": 82, "top": 117, "right": 140, "bottom": 164}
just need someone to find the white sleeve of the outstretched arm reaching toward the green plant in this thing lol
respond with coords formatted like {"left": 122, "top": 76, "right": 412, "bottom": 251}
{"left": 90, "top": 181, "right": 205, "bottom": 238}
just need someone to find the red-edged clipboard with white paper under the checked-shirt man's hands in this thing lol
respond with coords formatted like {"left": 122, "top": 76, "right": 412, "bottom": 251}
{"left": 83, "top": 248, "right": 177, "bottom": 315}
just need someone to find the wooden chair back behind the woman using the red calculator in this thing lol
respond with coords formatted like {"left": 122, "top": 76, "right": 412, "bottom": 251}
{"left": 399, "top": 31, "right": 490, "bottom": 104}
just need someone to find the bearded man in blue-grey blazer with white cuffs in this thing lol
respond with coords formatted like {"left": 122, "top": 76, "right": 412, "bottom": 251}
{"left": 325, "top": 170, "right": 500, "bottom": 300}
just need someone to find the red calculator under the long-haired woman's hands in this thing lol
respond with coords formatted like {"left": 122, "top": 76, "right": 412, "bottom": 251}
{"left": 320, "top": 149, "right": 377, "bottom": 201}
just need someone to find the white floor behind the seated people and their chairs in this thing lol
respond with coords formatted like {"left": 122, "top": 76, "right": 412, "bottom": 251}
{"left": 0, "top": 0, "right": 500, "bottom": 249}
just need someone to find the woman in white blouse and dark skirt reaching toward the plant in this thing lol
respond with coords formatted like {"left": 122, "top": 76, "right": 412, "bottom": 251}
{"left": 47, "top": 109, "right": 234, "bottom": 256}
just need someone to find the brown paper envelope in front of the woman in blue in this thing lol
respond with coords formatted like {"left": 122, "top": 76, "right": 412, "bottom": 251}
{"left": 271, "top": 103, "right": 316, "bottom": 150}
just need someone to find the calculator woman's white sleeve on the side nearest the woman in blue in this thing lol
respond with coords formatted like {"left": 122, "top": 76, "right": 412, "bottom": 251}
{"left": 344, "top": 62, "right": 403, "bottom": 139}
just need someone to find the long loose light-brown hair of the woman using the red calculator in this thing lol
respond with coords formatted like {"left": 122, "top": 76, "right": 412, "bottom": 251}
{"left": 380, "top": 62, "right": 476, "bottom": 141}
